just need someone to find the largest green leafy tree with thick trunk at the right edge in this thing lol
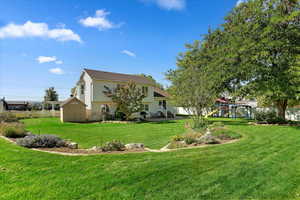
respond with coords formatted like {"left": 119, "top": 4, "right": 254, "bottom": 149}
{"left": 220, "top": 0, "right": 300, "bottom": 118}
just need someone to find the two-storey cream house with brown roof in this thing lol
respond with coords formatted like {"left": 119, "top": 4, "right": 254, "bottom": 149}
{"left": 73, "top": 69, "right": 175, "bottom": 121}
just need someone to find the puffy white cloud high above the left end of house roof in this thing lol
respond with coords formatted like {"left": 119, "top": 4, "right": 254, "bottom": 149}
{"left": 79, "top": 9, "right": 121, "bottom": 31}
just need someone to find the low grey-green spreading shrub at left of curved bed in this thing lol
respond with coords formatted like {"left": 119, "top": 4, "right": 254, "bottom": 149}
{"left": 17, "top": 135, "right": 66, "bottom": 148}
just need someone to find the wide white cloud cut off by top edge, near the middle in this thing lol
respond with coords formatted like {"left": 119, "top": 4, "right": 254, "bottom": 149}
{"left": 141, "top": 0, "right": 186, "bottom": 10}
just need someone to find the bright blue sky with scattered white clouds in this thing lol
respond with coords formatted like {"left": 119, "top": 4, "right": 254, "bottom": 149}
{"left": 0, "top": 0, "right": 237, "bottom": 100}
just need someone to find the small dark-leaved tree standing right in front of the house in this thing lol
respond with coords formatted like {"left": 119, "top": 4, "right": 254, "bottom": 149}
{"left": 103, "top": 81, "right": 145, "bottom": 120}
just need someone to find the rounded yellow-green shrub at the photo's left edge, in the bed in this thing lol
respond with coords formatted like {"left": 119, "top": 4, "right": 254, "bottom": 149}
{"left": 0, "top": 123, "right": 26, "bottom": 138}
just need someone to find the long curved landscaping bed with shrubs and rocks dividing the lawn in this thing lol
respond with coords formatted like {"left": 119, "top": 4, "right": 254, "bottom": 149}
{"left": 0, "top": 119, "right": 240, "bottom": 155}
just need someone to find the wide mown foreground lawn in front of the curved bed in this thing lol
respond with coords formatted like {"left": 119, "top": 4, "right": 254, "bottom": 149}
{"left": 0, "top": 120, "right": 300, "bottom": 200}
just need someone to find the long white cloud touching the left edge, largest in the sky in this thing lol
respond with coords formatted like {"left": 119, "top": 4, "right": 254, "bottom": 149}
{"left": 0, "top": 21, "right": 81, "bottom": 42}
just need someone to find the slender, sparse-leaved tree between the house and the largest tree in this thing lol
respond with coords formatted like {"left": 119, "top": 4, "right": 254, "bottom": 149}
{"left": 166, "top": 41, "right": 220, "bottom": 128}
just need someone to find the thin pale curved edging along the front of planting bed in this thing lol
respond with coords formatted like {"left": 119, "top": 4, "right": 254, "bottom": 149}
{"left": 0, "top": 135, "right": 240, "bottom": 156}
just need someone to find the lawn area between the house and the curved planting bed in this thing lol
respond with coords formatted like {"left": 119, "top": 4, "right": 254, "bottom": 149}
{"left": 23, "top": 118, "right": 184, "bottom": 148}
